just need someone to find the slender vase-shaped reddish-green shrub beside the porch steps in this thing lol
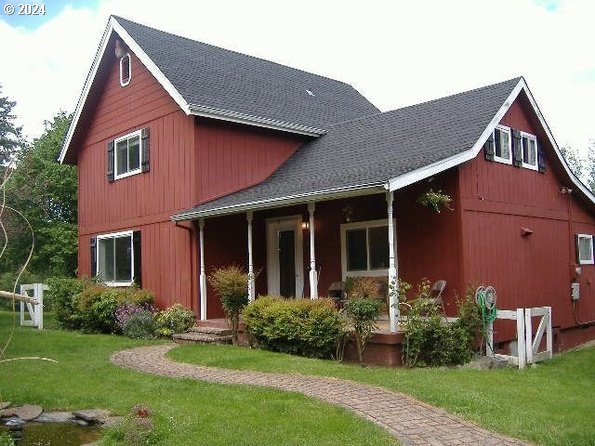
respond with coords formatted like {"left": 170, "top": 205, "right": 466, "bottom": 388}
{"left": 209, "top": 265, "right": 248, "bottom": 344}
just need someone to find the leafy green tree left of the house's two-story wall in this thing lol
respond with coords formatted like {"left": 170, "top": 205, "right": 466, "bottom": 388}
{"left": 0, "top": 112, "right": 77, "bottom": 276}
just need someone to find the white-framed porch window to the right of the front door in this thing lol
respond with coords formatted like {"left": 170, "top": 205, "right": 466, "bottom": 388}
{"left": 341, "top": 220, "right": 388, "bottom": 276}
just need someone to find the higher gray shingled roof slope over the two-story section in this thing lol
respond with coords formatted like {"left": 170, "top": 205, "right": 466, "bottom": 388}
{"left": 114, "top": 17, "right": 378, "bottom": 130}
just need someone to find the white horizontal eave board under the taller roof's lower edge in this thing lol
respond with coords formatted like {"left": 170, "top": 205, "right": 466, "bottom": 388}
{"left": 190, "top": 105, "right": 327, "bottom": 137}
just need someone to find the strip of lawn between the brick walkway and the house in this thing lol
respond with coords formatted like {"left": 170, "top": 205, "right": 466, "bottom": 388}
{"left": 169, "top": 345, "right": 595, "bottom": 446}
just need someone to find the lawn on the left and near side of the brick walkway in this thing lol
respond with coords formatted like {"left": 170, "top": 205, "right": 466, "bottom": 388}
{"left": 0, "top": 312, "right": 397, "bottom": 446}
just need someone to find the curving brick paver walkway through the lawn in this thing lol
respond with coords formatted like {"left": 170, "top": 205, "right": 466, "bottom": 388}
{"left": 111, "top": 344, "right": 526, "bottom": 446}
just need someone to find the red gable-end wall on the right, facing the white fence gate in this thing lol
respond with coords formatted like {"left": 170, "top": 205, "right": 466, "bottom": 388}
{"left": 459, "top": 97, "right": 595, "bottom": 339}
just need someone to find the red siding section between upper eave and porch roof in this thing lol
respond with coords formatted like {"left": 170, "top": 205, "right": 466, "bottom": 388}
{"left": 195, "top": 119, "right": 305, "bottom": 202}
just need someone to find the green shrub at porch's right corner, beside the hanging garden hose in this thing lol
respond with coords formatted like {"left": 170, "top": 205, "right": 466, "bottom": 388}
{"left": 403, "top": 287, "right": 481, "bottom": 367}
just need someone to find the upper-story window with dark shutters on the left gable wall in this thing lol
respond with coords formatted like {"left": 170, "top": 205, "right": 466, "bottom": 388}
{"left": 107, "top": 127, "right": 150, "bottom": 182}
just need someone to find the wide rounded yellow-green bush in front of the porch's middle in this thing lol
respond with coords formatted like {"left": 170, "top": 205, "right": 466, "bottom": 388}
{"left": 242, "top": 296, "right": 344, "bottom": 358}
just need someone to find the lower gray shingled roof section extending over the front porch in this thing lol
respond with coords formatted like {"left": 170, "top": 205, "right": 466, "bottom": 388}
{"left": 173, "top": 78, "right": 521, "bottom": 220}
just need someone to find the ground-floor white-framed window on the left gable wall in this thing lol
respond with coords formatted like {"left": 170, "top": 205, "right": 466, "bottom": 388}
{"left": 97, "top": 231, "right": 134, "bottom": 286}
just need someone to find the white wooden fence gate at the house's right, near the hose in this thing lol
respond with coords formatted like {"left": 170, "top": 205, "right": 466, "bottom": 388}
{"left": 486, "top": 307, "right": 553, "bottom": 369}
